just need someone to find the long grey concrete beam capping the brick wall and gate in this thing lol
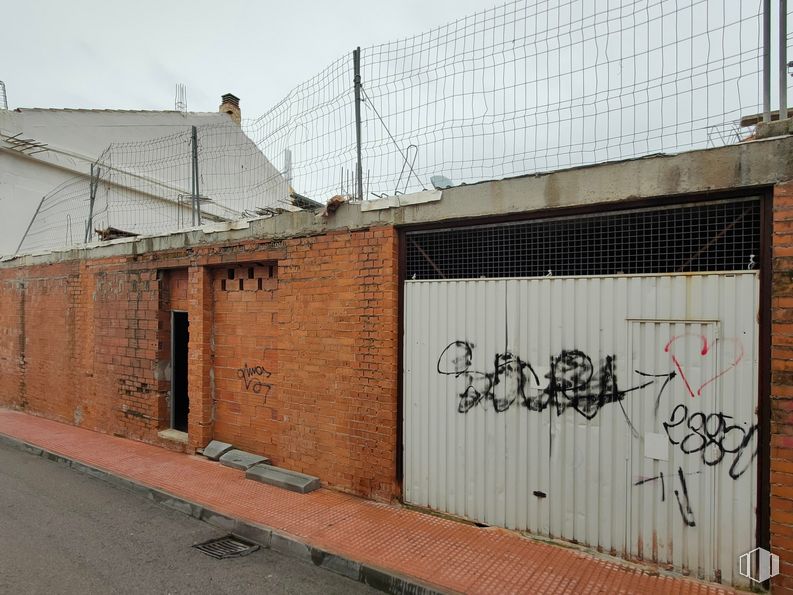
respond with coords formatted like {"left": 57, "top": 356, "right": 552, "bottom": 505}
{"left": 0, "top": 136, "right": 793, "bottom": 267}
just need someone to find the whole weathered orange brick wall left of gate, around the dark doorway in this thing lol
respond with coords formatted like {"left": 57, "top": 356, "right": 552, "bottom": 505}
{"left": 0, "top": 228, "right": 398, "bottom": 500}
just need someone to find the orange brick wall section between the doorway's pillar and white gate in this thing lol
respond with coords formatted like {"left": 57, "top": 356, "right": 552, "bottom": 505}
{"left": 207, "top": 228, "right": 398, "bottom": 499}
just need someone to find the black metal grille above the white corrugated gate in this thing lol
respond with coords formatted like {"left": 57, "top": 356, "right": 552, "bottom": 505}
{"left": 406, "top": 198, "right": 760, "bottom": 279}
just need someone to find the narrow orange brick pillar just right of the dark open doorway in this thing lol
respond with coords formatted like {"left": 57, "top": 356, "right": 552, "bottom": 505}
{"left": 187, "top": 266, "right": 214, "bottom": 450}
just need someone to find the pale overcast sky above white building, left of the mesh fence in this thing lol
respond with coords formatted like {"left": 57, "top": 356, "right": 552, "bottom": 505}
{"left": 6, "top": 0, "right": 497, "bottom": 118}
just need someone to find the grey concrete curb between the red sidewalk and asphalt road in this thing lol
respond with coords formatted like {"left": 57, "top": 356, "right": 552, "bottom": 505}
{"left": 0, "top": 433, "right": 444, "bottom": 595}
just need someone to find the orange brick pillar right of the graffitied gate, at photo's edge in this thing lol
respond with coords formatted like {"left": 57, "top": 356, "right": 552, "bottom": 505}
{"left": 770, "top": 183, "right": 793, "bottom": 594}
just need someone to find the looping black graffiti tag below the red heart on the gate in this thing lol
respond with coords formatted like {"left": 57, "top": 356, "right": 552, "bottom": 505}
{"left": 663, "top": 403, "right": 757, "bottom": 479}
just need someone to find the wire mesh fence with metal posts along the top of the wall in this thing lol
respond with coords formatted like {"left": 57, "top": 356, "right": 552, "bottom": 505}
{"left": 17, "top": 0, "right": 789, "bottom": 254}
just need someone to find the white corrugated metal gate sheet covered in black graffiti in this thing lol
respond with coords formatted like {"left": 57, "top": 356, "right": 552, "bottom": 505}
{"left": 404, "top": 272, "right": 759, "bottom": 585}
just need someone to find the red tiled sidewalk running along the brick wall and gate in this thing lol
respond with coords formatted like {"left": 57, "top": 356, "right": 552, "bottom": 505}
{"left": 0, "top": 409, "right": 733, "bottom": 594}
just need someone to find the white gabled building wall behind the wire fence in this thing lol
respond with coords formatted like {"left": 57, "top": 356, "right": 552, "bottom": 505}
{"left": 0, "top": 109, "right": 287, "bottom": 254}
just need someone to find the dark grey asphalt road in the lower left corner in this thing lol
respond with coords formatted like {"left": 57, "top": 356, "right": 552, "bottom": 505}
{"left": 0, "top": 445, "right": 375, "bottom": 595}
